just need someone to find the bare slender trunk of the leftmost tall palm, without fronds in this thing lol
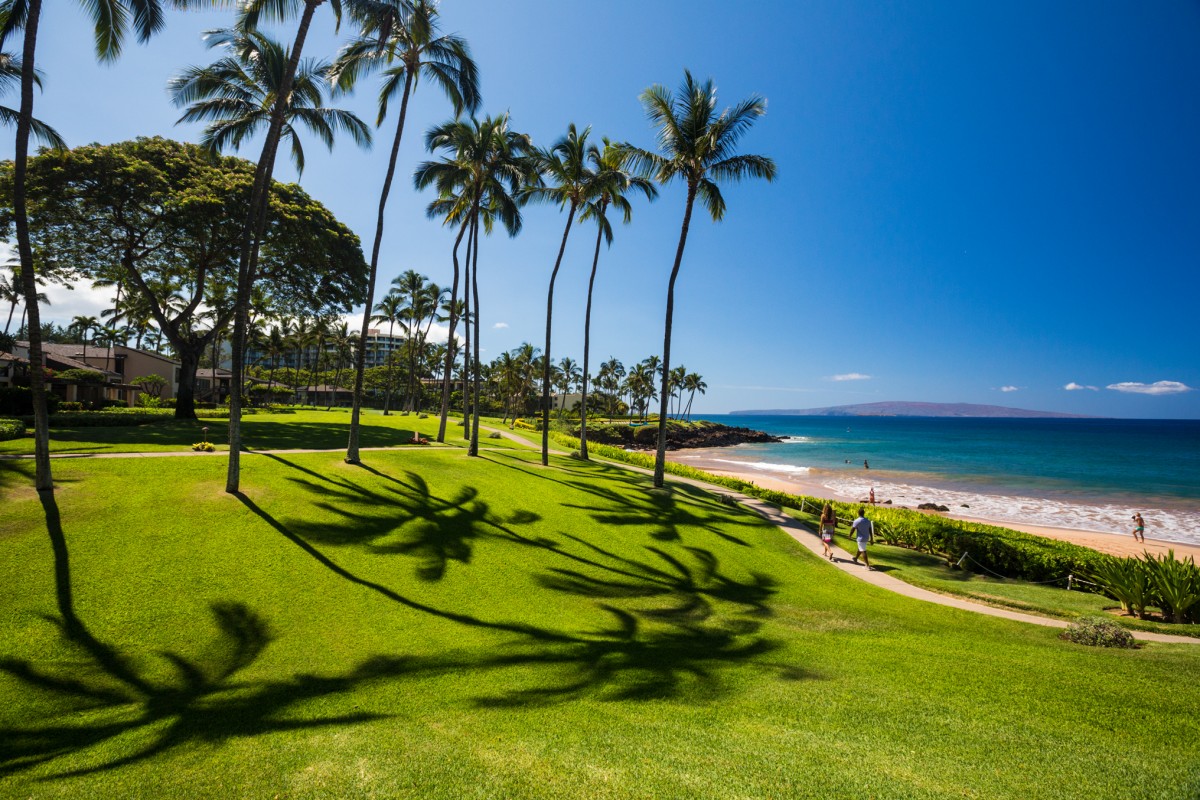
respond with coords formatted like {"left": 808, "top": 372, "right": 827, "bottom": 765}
{"left": 13, "top": 0, "right": 54, "bottom": 492}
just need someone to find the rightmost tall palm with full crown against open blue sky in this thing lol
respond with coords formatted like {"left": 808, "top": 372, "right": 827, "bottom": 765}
{"left": 630, "top": 71, "right": 775, "bottom": 487}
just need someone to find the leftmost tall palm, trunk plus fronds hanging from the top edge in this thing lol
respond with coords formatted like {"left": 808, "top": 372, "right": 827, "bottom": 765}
{"left": 0, "top": 0, "right": 174, "bottom": 492}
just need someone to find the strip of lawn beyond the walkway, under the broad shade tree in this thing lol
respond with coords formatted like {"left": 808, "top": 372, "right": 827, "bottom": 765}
{"left": 0, "top": 409, "right": 530, "bottom": 455}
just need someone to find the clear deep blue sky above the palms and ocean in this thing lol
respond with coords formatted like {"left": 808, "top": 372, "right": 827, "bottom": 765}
{"left": 0, "top": 0, "right": 1200, "bottom": 417}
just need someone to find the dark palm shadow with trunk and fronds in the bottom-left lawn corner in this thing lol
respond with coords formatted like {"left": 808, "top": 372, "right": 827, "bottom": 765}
{"left": 0, "top": 492, "right": 407, "bottom": 780}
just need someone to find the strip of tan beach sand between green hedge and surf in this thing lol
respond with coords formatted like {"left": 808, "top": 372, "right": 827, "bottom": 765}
{"left": 667, "top": 450, "right": 1200, "bottom": 563}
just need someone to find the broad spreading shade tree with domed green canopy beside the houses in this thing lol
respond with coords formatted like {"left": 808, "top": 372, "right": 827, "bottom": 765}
{"left": 0, "top": 138, "right": 366, "bottom": 417}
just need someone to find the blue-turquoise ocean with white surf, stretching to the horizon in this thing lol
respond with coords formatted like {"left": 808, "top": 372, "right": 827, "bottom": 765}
{"left": 674, "top": 415, "right": 1200, "bottom": 545}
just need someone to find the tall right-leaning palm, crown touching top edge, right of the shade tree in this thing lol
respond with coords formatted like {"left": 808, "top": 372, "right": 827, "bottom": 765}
{"left": 334, "top": 0, "right": 480, "bottom": 463}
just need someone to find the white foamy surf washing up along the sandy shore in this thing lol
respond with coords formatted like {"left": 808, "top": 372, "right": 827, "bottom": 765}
{"left": 823, "top": 479, "right": 1200, "bottom": 545}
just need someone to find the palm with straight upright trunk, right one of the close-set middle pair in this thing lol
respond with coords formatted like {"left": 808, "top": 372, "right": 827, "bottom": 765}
{"left": 414, "top": 114, "right": 532, "bottom": 456}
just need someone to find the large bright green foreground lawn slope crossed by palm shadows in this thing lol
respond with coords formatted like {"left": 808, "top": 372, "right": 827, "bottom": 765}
{"left": 0, "top": 449, "right": 1200, "bottom": 798}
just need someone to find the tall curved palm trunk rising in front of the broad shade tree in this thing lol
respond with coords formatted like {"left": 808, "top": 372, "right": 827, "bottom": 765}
{"left": 225, "top": 0, "right": 323, "bottom": 494}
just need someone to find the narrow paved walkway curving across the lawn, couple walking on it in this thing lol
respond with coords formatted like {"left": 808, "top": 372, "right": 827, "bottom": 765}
{"left": 0, "top": 425, "right": 1200, "bottom": 644}
